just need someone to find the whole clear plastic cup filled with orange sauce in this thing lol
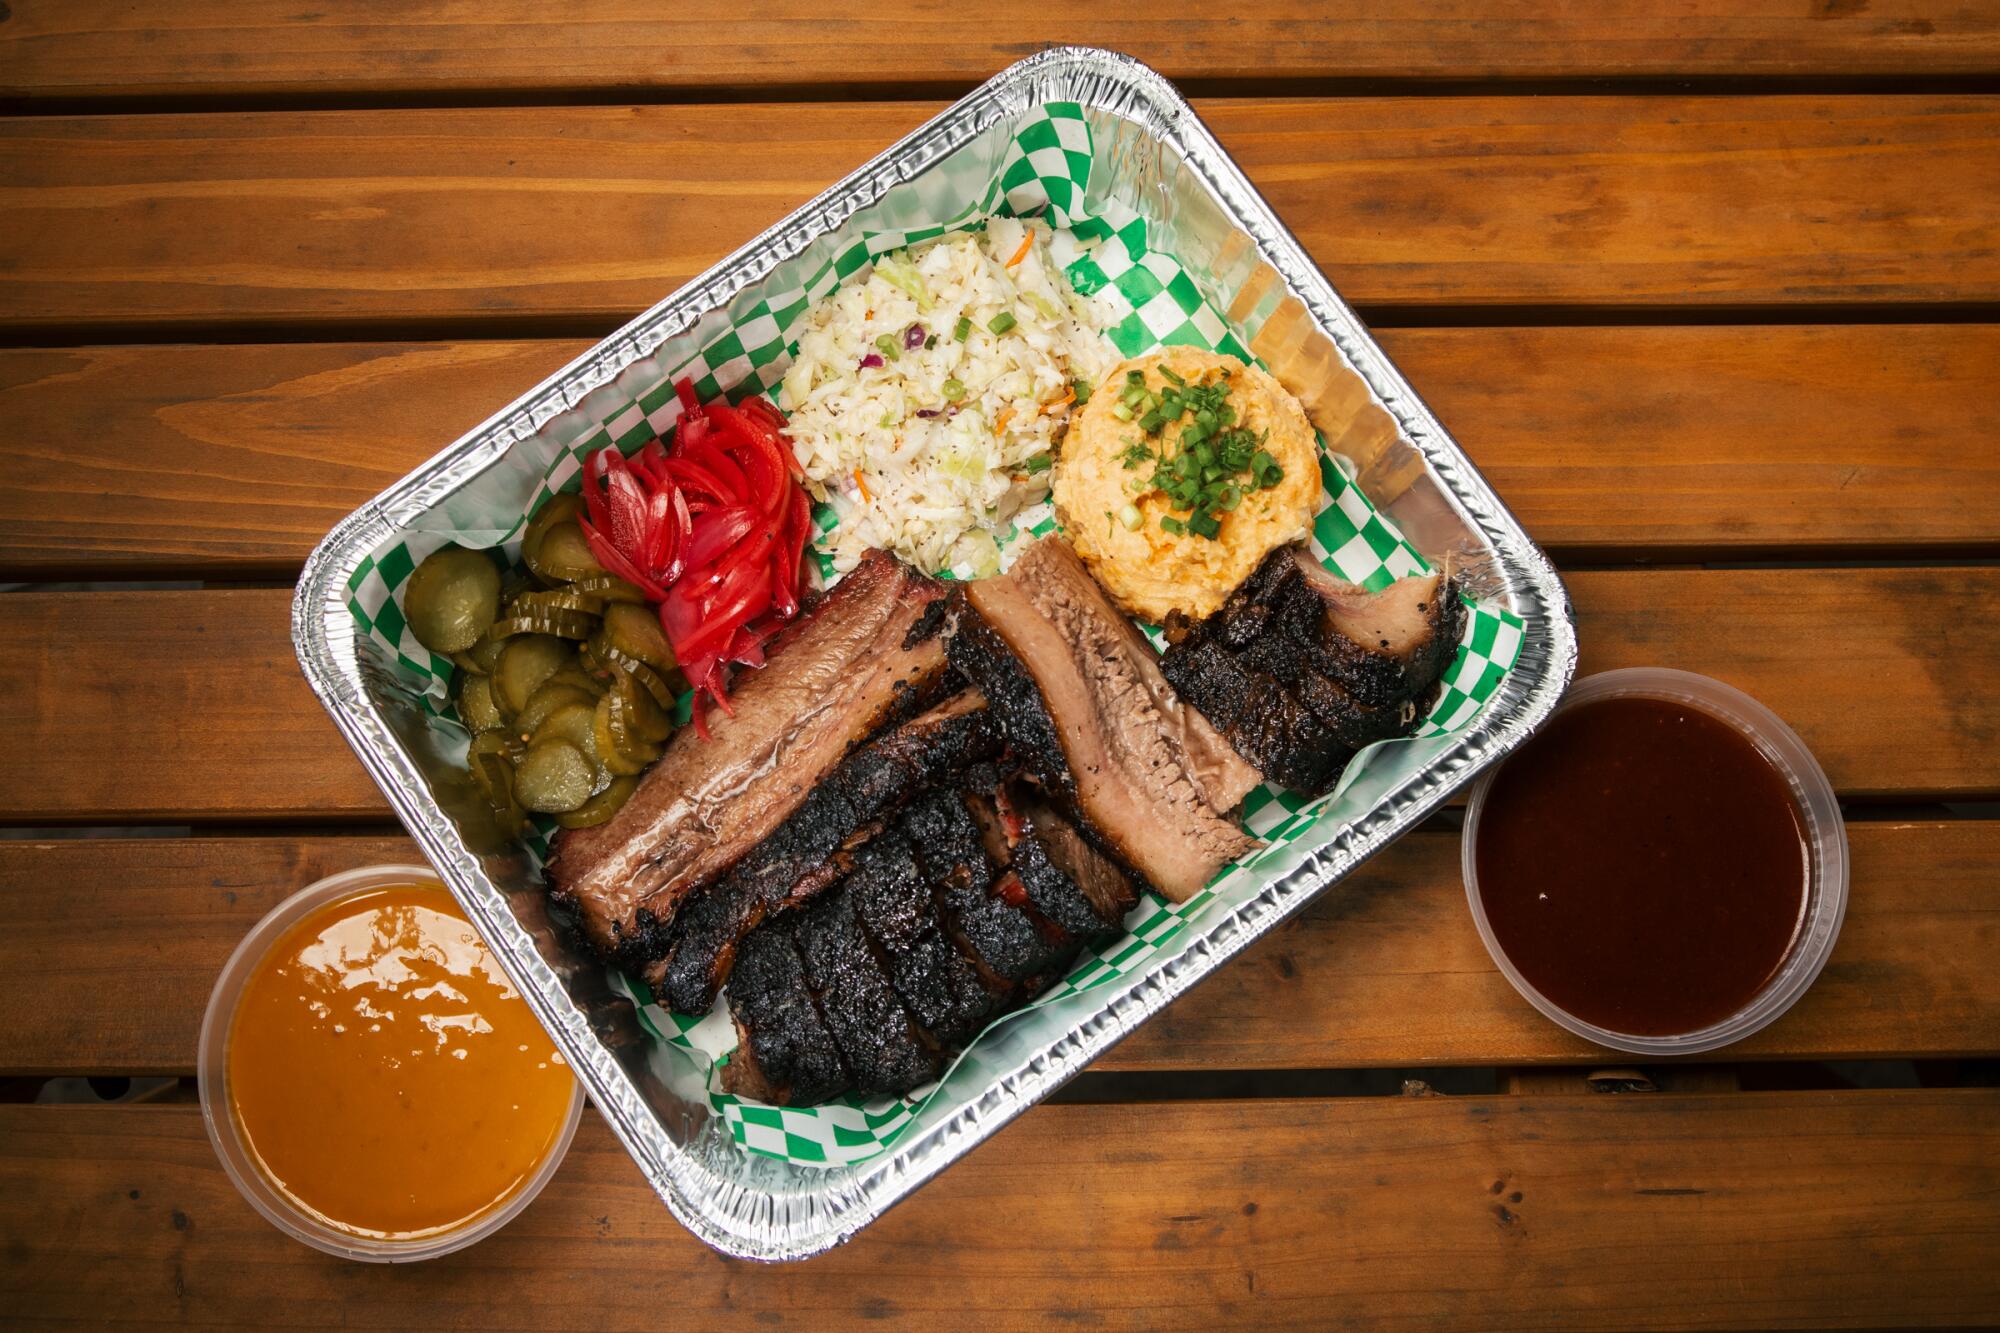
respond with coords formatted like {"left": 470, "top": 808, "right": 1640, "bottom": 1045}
{"left": 198, "top": 865, "right": 584, "bottom": 1263}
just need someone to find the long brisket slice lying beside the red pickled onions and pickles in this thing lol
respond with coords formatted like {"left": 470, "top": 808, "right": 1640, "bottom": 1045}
{"left": 548, "top": 552, "right": 948, "bottom": 967}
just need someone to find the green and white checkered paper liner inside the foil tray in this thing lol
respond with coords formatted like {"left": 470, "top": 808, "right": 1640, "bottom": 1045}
{"left": 348, "top": 102, "right": 1522, "bottom": 1167}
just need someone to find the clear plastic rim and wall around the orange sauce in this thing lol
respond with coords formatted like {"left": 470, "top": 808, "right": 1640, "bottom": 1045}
{"left": 196, "top": 865, "right": 584, "bottom": 1263}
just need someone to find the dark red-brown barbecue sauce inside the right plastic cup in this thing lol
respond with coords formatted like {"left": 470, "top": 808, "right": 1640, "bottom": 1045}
{"left": 1476, "top": 699, "right": 1810, "bottom": 1037}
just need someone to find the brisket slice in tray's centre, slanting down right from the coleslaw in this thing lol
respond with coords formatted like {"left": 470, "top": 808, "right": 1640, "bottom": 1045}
{"left": 952, "top": 536, "right": 1262, "bottom": 901}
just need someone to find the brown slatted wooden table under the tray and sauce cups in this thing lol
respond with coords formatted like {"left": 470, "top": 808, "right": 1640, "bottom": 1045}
{"left": 0, "top": 0, "right": 2000, "bottom": 1331}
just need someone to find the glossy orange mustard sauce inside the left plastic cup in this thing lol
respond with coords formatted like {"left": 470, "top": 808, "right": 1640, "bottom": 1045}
{"left": 228, "top": 885, "right": 574, "bottom": 1241}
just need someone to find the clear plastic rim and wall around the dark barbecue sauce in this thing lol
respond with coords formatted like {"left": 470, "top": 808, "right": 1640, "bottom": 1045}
{"left": 1460, "top": 667, "right": 1848, "bottom": 1055}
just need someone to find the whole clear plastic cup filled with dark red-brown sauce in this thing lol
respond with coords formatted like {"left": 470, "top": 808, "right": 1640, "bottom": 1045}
{"left": 1462, "top": 667, "right": 1848, "bottom": 1055}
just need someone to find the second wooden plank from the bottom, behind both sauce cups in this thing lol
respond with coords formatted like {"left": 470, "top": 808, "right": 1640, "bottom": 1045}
{"left": 0, "top": 823, "right": 2000, "bottom": 1075}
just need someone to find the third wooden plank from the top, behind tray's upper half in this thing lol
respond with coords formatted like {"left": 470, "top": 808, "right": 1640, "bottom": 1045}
{"left": 0, "top": 324, "right": 2000, "bottom": 578}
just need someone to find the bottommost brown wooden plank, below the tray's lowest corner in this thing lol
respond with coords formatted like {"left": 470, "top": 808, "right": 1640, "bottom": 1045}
{"left": 0, "top": 1091, "right": 2000, "bottom": 1329}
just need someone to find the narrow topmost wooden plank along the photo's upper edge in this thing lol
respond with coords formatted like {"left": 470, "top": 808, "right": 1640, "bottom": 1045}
{"left": 0, "top": 0, "right": 2000, "bottom": 100}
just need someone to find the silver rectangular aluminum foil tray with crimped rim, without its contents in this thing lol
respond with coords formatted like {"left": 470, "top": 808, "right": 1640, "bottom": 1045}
{"left": 294, "top": 48, "right": 1576, "bottom": 1259}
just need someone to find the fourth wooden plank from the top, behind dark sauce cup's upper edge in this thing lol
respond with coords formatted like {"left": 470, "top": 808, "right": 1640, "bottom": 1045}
{"left": 0, "top": 568, "right": 2000, "bottom": 823}
